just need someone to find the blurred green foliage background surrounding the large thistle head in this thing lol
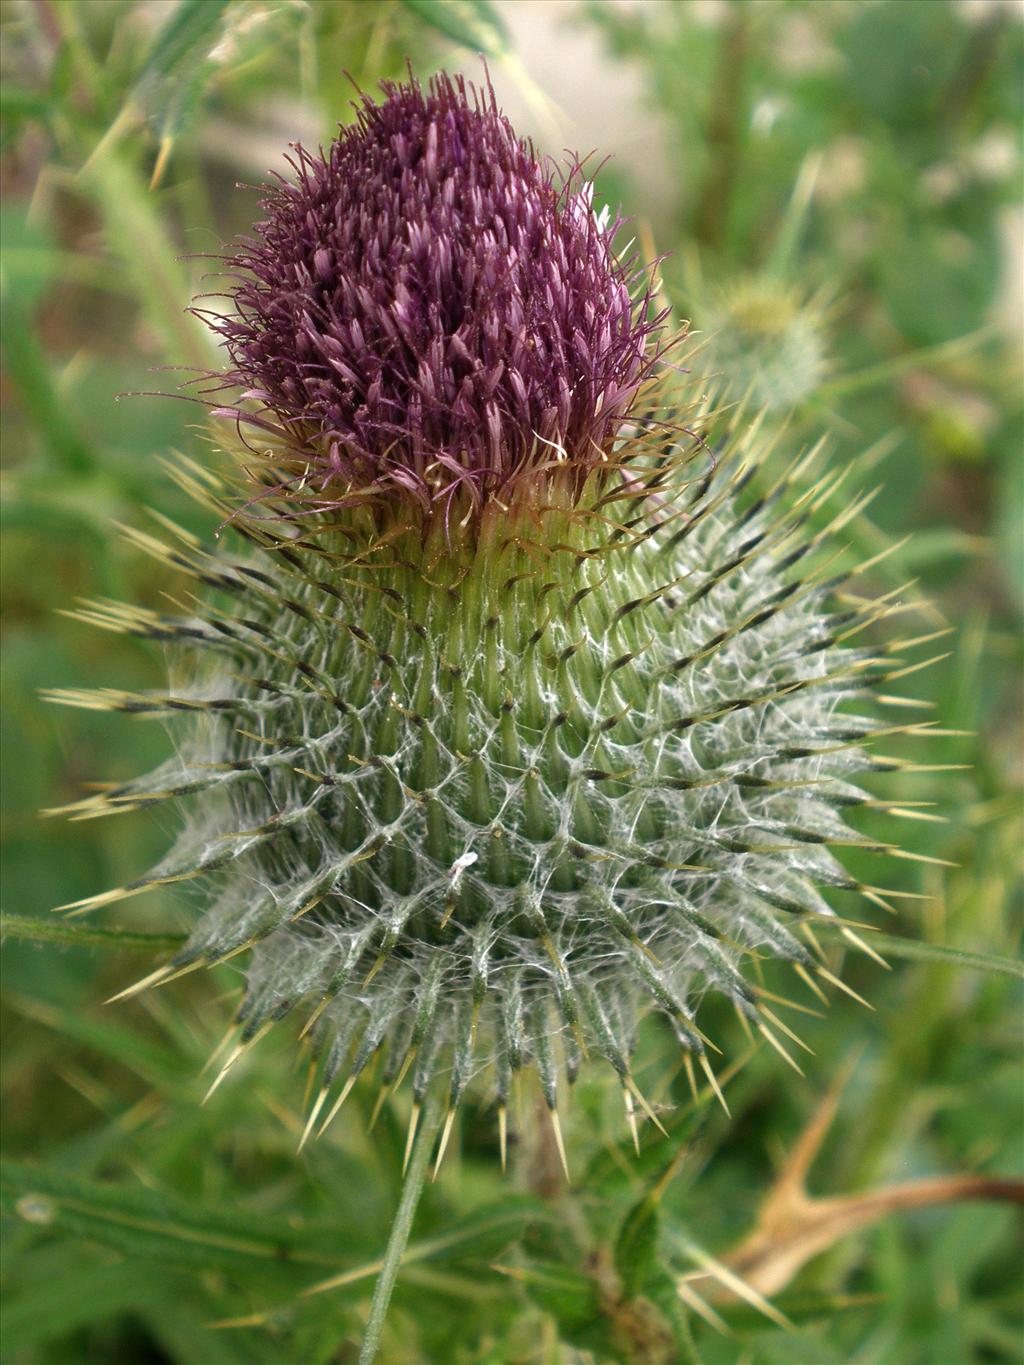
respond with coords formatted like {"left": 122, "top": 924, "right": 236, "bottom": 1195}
{"left": 0, "top": 0, "right": 1024, "bottom": 1365}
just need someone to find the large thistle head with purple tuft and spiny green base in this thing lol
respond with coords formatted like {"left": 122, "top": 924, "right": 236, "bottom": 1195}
{"left": 54, "top": 76, "right": 906, "bottom": 1157}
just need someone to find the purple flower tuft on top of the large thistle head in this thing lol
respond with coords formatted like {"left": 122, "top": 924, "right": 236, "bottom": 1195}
{"left": 210, "top": 74, "right": 662, "bottom": 506}
